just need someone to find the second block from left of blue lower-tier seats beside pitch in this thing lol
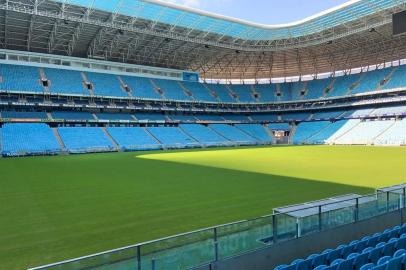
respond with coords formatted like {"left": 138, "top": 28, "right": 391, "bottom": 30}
{"left": 58, "top": 127, "right": 115, "bottom": 153}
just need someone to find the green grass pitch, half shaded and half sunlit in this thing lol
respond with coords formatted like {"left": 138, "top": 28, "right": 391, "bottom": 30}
{"left": 0, "top": 146, "right": 406, "bottom": 270}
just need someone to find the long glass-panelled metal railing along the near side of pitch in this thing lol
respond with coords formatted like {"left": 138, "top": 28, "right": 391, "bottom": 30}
{"left": 30, "top": 186, "right": 406, "bottom": 270}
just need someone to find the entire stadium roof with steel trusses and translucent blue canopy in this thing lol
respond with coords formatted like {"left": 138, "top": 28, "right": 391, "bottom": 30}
{"left": 0, "top": 0, "right": 406, "bottom": 79}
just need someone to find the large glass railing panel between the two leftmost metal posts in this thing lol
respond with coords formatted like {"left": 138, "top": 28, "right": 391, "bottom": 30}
{"left": 141, "top": 229, "right": 215, "bottom": 270}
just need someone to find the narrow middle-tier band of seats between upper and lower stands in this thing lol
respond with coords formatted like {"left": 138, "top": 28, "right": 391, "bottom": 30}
{"left": 0, "top": 106, "right": 406, "bottom": 122}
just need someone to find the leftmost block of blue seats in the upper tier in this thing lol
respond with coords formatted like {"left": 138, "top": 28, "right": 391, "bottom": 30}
{"left": 0, "top": 64, "right": 45, "bottom": 93}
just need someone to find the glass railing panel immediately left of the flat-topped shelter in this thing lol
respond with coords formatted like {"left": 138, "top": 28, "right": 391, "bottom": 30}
{"left": 217, "top": 216, "right": 273, "bottom": 259}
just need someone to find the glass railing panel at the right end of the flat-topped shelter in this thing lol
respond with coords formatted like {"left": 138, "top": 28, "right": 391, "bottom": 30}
{"left": 321, "top": 199, "right": 356, "bottom": 230}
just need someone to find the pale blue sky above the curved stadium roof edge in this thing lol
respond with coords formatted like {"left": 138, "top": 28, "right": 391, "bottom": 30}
{"left": 162, "top": 0, "right": 348, "bottom": 24}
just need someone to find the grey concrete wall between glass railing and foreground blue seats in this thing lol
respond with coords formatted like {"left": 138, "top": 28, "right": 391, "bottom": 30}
{"left": 194, "top": 209, "right": 406, "bottom": 270}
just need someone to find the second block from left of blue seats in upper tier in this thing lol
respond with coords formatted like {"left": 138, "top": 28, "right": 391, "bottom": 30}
{"left": 44, "top": 68, "right": 90, "bottom": 95}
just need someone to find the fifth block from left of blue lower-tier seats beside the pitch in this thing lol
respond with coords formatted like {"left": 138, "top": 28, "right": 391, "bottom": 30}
{"left": 180, "top": 124, "right": 232, "bottom": 146}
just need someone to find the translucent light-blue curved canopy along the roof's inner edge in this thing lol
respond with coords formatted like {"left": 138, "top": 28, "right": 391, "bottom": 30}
{"left": 58, "top": 0, "right": 401, "bottom": 41}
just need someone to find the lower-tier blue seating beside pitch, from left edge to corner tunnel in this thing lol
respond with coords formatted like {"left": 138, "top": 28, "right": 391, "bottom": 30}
{"left": 0, "top": 123, "right": 272, "bottom": 156}
